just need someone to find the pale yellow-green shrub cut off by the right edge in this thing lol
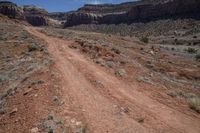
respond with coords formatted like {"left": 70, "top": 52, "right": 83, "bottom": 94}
{"left": 188, "top": 97, "right": 200, "bottom": 113}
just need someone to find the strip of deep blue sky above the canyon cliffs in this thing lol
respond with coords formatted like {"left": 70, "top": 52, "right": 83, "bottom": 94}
{"left": 7, "top": 0, "right": 134, "bottom": 12}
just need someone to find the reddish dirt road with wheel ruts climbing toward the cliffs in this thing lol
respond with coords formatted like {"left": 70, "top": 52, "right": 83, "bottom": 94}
{"left": 26, "top": 27, "right": 200, "bottom": 133}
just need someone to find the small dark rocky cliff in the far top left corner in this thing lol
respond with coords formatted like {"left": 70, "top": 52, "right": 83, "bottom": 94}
{"left": 0, "top": 1, "right": 23, "bottom": 18}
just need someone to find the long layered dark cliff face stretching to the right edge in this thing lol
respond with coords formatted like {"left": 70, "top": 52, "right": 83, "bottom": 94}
{"left": 64, "top": 0, "right": 200, "bottom": 27}
